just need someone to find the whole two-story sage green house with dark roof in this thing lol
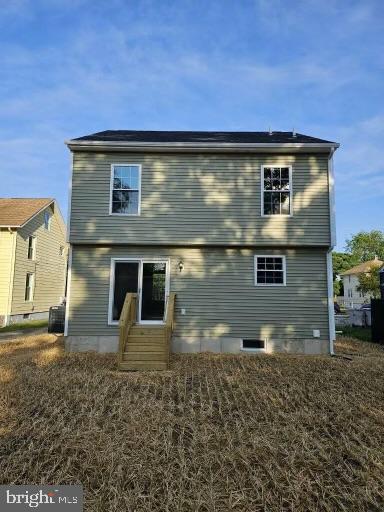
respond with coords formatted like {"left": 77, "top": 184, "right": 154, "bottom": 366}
{"left": 66, "top": 130, "right": 338, "bottom": 366}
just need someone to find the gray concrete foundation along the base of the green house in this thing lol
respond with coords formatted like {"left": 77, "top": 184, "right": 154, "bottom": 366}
{"left": 65, "top": 336, "right": 329, "bottom": 355}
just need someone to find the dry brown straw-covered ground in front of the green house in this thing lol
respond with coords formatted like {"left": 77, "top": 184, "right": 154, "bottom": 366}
{"left": 0, "top": 335, "right": 384, "bottom": 512}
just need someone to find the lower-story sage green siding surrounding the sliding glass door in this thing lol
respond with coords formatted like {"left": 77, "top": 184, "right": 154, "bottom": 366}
{"left": 68, "top": 246, "right": 329, "bottom": 340}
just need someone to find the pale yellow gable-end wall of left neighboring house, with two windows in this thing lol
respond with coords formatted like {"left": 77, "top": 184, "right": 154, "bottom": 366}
{"left": 12, "top": 207, "right": 67, "bottom": 315}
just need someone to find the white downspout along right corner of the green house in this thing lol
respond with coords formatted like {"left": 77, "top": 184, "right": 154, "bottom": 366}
{"left": 327, "top": 148, "right": 336, "bottom": 356}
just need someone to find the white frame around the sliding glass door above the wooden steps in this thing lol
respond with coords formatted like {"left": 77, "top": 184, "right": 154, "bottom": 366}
{"left": 108, "top": 256, "right": 171, "bottom": 326}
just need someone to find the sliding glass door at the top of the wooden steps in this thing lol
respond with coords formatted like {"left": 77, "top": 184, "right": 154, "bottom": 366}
{"left": 112, "top": 259, "right": 169, "bottom": 324}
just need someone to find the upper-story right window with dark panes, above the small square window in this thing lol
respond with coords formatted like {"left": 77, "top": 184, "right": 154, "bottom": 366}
{"left": 261, "top": 166, "right": 292, "bottom": 215}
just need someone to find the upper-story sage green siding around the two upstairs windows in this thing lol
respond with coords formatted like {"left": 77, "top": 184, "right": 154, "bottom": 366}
{"left": 70, "top": 151, "right": 330, "bottom": 246}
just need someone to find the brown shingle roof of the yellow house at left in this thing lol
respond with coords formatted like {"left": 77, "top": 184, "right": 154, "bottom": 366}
{"left": 0, "top": 198, "right": 54, "bottom": 228}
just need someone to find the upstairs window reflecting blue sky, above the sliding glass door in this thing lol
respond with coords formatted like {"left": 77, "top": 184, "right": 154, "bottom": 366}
{"left": 110, "top": 164, "right": 141, "bottom": 215}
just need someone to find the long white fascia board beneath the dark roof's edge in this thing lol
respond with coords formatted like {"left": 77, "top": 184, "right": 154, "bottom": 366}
{"left": 65, "top": 140, "right": 339, "bottom": 153}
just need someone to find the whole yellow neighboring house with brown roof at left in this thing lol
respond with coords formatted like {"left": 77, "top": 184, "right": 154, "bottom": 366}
{"left": 0, "top": 198, "right": 68, "bottom": 326}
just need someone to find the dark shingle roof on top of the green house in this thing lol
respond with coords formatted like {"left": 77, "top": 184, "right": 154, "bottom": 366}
{"left": 72, "top": 130, "right": 334, "bottom": 144}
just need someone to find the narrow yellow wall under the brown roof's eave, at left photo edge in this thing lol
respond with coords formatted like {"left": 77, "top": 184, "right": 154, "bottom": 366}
{"left": 0, "top": 229, "right": 16, "bottom": 325}
